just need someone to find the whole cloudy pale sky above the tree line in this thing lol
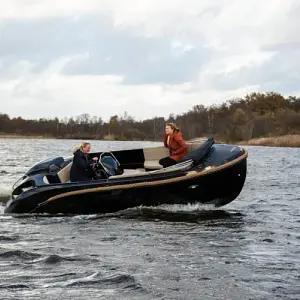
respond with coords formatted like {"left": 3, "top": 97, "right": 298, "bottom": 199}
{"left": 0, "top": 0, "right": 300, "bottom": 119}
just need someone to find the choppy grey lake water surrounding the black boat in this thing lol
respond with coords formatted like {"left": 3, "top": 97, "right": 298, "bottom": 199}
{"left": 0, "top": 140, "right": 300, "bottom": 300}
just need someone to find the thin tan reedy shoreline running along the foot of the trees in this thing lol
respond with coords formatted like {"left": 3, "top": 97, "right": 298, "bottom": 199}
{"left": 0, "top": 133, "right": 300, "bottom": 148}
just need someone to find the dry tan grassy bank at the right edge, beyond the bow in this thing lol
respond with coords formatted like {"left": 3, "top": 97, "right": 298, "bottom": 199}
{"left": 238, "top": 134, "right": 300, "bottom": 147}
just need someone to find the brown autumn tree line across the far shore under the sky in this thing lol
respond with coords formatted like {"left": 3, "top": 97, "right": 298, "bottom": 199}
{"left": 0, "top": 92, "right": 300, "bottom": 142}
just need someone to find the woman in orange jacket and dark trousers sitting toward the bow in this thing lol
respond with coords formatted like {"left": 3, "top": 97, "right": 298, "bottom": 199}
{"left": 159, "top": 123, "right": 188, "bottom": 168}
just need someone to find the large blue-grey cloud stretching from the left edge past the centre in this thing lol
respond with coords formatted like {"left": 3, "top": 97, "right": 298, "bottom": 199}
{"left": 0, "top": 16, "right": 212, "bottom": 84}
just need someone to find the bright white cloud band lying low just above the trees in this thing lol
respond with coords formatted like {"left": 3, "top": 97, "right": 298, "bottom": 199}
{"left": 0, "top": 56, "right": 255, "bottom": 119}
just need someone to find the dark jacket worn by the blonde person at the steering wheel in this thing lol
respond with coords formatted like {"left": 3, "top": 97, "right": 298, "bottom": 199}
{"left": 70, "top": 150, "right": 92, "bottom": 182}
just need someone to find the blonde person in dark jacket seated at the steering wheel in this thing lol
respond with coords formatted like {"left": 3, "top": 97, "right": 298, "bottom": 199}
{"left": 70, "top": 142, "right": 98, "bottom": 182}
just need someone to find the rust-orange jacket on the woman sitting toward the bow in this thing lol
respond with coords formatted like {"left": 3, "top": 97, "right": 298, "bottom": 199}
{"left": 163, "top": 131, "right": 188, "bottom": 161}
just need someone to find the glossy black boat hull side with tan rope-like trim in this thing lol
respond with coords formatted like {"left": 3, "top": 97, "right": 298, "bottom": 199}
{"left": 5, "top": 155, "right": 247, "bottom": 214}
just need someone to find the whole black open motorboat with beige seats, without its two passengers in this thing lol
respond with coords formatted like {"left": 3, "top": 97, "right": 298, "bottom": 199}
{"left": 5, "top": 138, "right": 248, "bottom": 214}
